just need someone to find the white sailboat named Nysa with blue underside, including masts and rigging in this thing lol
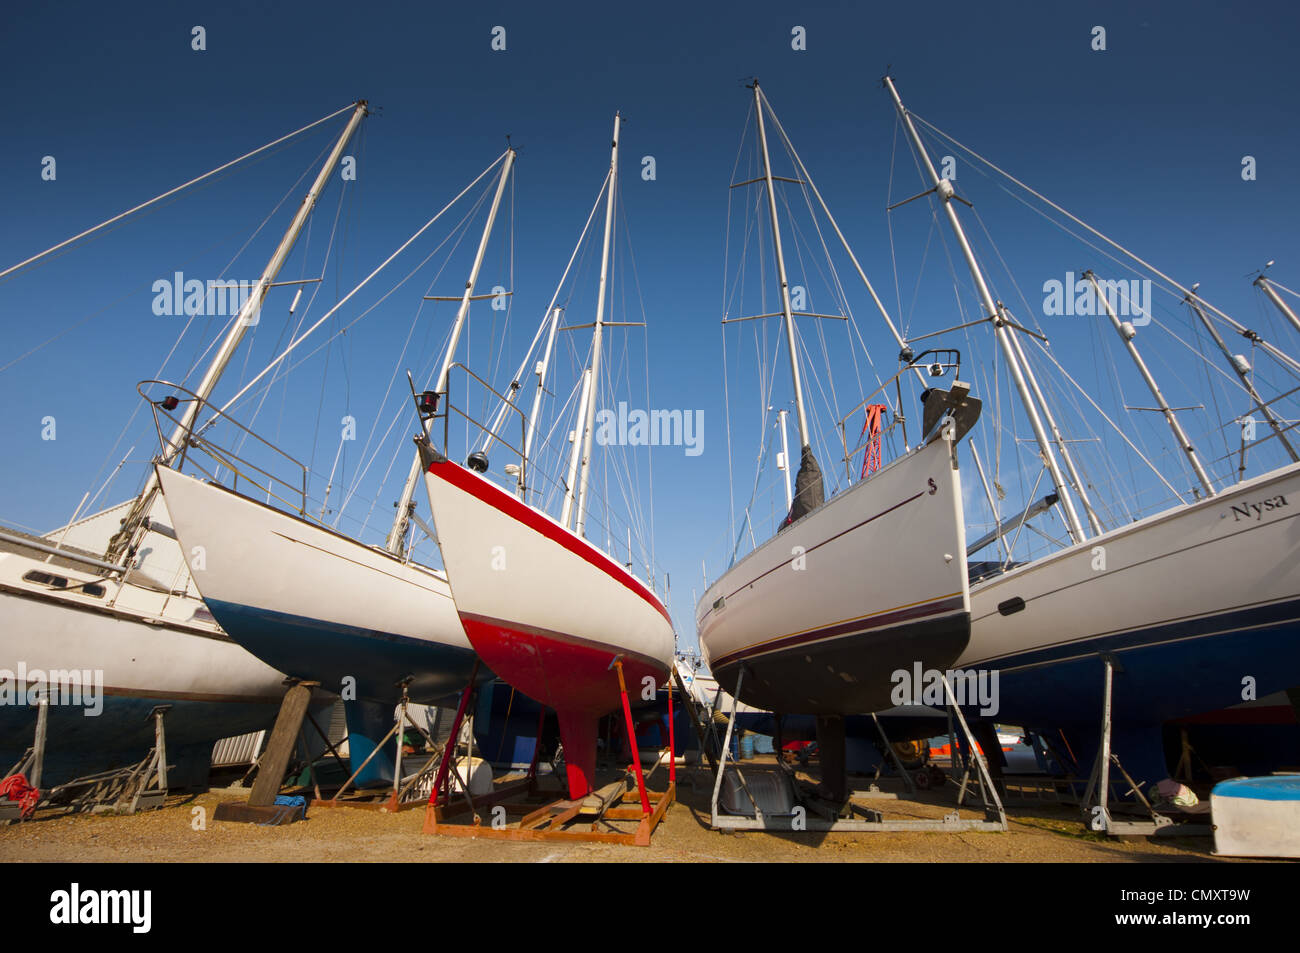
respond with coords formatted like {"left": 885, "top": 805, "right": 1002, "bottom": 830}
{"left": 884, "top": 77, "right": 1300, "bottom": 781}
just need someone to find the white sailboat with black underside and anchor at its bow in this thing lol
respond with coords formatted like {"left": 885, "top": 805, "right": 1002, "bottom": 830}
{"left": 696, "top": 81, "right": 979, "bottom": 801}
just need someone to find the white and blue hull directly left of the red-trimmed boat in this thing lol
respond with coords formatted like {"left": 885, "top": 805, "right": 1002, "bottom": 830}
{"left": 159, "top": 468, "right": 478, "bottom": 703}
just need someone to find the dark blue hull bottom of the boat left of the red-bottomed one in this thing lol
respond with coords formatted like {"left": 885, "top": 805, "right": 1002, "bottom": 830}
{"left": 207, "top": 599, "right": 491, "bottom": 705}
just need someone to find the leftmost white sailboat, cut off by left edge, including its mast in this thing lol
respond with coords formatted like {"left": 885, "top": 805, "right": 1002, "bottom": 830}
{"left": 0, "top": 100, "right": 368, "bottom": 785}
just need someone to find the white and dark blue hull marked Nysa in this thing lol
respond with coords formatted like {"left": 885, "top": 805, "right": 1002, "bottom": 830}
{"left": 957, "top": 464, "right": 1300, "bottom": 780}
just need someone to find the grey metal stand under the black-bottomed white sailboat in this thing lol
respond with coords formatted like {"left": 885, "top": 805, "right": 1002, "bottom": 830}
{"left": 710, "top": 666, "right": 1006, "bottom": 833}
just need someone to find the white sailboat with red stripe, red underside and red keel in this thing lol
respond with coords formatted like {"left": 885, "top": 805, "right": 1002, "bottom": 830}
{"left": 419, "top": 117, "right": 675, "bottom": 798}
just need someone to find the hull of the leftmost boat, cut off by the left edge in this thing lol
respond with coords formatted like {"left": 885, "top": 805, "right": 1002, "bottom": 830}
{"left": 0, "top": 553, "right": 285, "bottom": 788}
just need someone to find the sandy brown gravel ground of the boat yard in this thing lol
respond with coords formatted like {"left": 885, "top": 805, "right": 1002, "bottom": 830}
{"left": 0, "top": 767, "right": 1258, "bottom": 863}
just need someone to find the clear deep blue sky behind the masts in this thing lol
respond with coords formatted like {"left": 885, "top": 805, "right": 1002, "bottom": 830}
{"left": 0, "top": 3, "right": 1300, "bottom": 645}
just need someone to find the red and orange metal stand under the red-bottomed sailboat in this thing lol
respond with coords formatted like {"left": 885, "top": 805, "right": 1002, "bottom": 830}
{"left": 423, "top": 655, "right": 677, "bottom": 846}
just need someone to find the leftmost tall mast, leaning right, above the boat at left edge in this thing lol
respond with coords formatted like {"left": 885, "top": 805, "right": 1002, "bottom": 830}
{"left": 108, "top": 99, "right": 369, "bottom": 563}
